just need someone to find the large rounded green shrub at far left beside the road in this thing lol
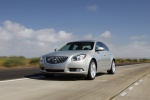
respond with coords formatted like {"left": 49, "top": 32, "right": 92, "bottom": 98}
{"left": 3, "top": 57, "right": 25, "bottom": 67}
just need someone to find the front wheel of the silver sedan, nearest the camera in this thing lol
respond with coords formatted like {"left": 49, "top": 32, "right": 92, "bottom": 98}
{"left": 87, "top": 60, "right": 96, "bottom": 80}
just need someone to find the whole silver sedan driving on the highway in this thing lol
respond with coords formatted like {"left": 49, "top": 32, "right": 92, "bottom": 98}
{"left": 40, "top": 40, "right": 116, "bottom": 80}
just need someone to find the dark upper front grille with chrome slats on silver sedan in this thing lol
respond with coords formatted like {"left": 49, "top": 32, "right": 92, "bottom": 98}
{"left": 46, "top": 56, "right": 68, "bottom": 64}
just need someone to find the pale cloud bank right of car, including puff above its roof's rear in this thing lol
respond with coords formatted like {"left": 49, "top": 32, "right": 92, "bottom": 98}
{"left": 85, "top": 31, "right": 150, "bottom": 58}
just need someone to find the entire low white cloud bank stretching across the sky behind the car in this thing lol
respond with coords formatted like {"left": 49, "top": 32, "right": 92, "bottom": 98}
{"left": 0, "top": 21, "right": 150, "bottom": 58}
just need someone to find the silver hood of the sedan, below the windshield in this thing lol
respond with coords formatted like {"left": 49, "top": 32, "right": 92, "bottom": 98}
{"left": 45, "top": 50, "right": 93, "bottom": 57}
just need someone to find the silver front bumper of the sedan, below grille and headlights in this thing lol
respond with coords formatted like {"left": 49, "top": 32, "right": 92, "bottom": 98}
{"left": 40, "top": 57, "right": 91, "bottom": 75}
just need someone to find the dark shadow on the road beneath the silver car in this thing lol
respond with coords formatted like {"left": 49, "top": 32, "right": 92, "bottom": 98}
{"left": 24, "top": 73, "right": 107, "bottom": 81}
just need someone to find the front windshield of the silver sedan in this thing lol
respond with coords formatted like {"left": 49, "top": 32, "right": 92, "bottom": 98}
{"left": 58, "top": 42, "right": 94, "bottom": 51}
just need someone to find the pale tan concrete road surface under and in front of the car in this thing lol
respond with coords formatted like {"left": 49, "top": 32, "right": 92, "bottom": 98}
{"left": 0, "top": 63, "right": 150, "bottom": 100}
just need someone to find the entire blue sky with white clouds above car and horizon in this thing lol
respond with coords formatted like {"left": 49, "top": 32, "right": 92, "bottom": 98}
{"left": 0, "top": 0, "right": 150, "bottom": 57}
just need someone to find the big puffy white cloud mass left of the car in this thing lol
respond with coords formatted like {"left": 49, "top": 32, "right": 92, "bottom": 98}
{"left": 0, "top": 21, "right": 74, "bottom": 57}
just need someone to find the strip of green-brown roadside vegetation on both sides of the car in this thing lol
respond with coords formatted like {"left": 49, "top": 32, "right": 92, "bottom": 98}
{"left": 0, "top": 56, "right": 150, "bottom": 69}
